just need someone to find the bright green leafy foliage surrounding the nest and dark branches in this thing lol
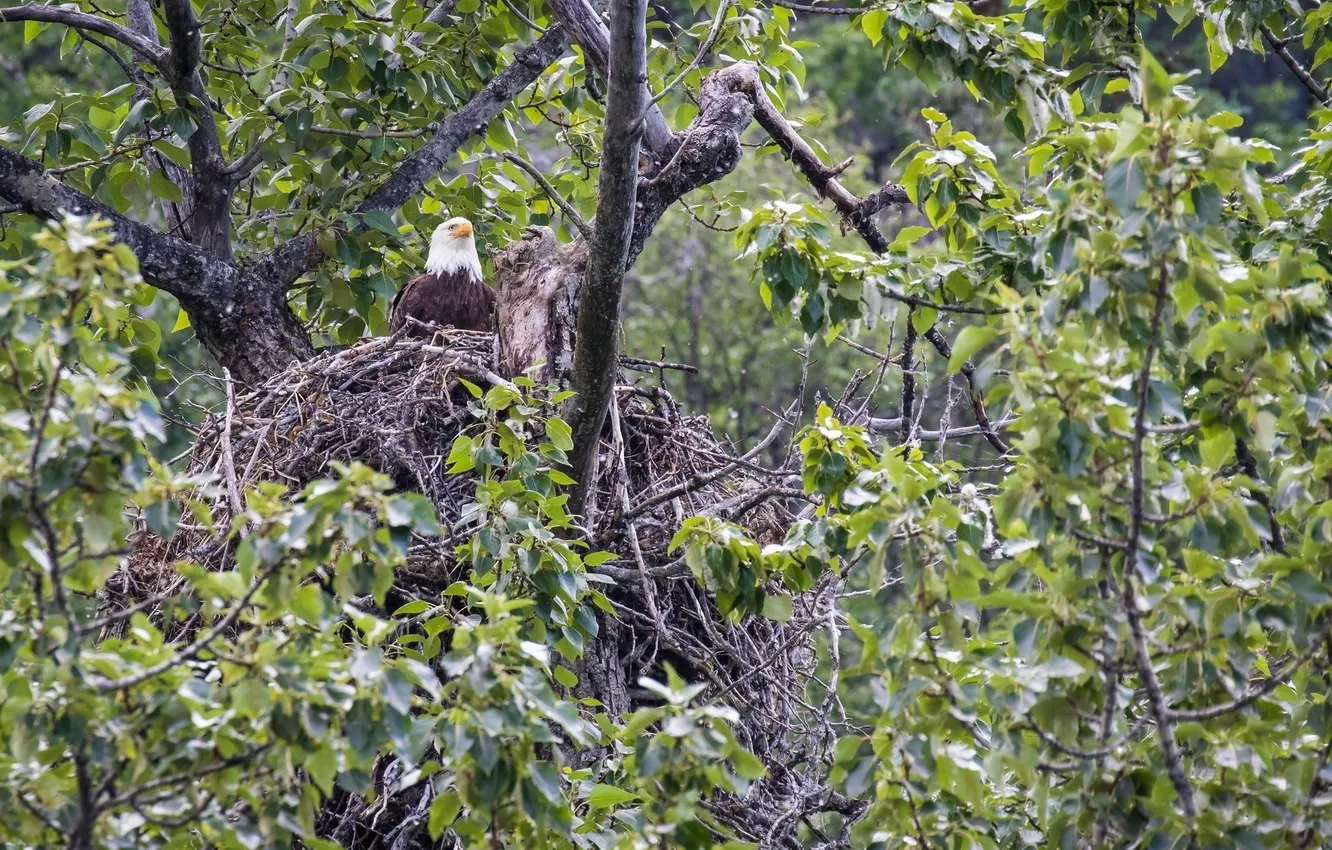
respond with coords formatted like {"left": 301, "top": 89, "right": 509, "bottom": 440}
{"left": 0, "top": 0, "right": 1332, "bottom": 850}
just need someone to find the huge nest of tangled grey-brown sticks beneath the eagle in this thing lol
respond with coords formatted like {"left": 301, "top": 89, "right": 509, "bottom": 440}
{"left": 107, "top": 330, "right": 852, "bottom": 849}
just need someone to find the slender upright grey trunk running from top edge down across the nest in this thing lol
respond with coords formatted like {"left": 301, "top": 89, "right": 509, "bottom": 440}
{"left": 566, "top": 0, "right": 649, "bottom": 514}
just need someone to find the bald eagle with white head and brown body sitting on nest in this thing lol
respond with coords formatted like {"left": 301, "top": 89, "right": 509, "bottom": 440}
{"left": 389, "top": 218, "right": 496, "bottom": 336}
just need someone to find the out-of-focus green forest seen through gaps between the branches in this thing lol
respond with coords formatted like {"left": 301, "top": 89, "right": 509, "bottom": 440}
{"left": 0, "top": 8, "right": 1313, "bottom": 453}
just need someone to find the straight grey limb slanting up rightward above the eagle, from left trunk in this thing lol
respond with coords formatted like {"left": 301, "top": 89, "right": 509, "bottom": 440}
{"left": 258, "top": 25, "right": 569, "bottom": 292}
